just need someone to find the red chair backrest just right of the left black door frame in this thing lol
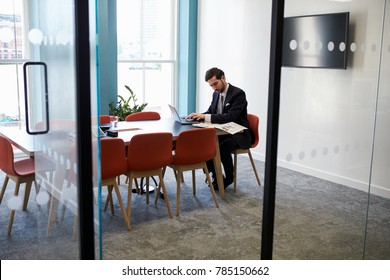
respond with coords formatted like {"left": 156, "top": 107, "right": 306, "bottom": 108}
{"left": 100, "top": 138, "right": 127, "bottom": 180}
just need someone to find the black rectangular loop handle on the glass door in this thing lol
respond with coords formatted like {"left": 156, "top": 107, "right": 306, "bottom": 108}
{"left": 23, "top": 61, "right": 50, "bottom": 135}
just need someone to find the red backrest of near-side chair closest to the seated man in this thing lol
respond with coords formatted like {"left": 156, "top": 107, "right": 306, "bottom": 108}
{"left": 173, "top": 128, "right": 217, "bottom": 165}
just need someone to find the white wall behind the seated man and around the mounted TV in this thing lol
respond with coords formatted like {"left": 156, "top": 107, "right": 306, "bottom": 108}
{"left": 197, "top": 0, "right": 390, "bottom": 197}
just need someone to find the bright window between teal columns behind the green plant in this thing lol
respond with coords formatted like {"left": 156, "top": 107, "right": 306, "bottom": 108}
{"left": 117, "top": 0, "right": 177, "bottom": 115}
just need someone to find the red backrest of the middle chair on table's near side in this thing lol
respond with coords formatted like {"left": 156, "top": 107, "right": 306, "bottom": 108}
{"left": 127, "top": 132, "right": 172, "bottom": 171}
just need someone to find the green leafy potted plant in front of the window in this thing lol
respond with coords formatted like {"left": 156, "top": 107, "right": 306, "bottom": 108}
{"left": 108, "top": 85, "right": 148, "bottom": 121}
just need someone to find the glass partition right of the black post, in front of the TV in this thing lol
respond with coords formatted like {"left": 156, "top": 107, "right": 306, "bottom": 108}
{"left": 273, "top": 0, "right": 390, "bottom": 259}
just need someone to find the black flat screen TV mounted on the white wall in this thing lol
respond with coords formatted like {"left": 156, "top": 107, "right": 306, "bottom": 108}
{"left": 282, "top": 12, "right": 349, "bottom": 69}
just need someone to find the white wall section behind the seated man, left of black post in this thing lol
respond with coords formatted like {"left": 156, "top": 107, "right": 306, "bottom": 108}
{"left": 197, "top": 0, "right": 271, "bottom": 159}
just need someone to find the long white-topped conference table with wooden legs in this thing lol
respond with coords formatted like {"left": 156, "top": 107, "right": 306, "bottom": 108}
{"left": 0, "top": 118, "right": 227, "bottom": 225}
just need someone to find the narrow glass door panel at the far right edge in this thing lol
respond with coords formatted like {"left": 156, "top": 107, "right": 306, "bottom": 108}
{"left": 364, "top": 2, "right": 390, "bottom": 260}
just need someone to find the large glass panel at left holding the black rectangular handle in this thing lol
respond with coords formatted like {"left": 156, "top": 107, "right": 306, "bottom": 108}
{"left": 0, "top": 0, "right": 100, "bottom": 259}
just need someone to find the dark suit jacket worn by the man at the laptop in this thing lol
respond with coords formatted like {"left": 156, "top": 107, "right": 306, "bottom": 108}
{"left": 203, "top": 84, "right": 252, "bottom": 149}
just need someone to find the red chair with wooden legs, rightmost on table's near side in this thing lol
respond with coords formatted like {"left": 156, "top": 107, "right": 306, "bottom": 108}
{"left": 163, "top": 128, "right": 219, "bottom": 216}
